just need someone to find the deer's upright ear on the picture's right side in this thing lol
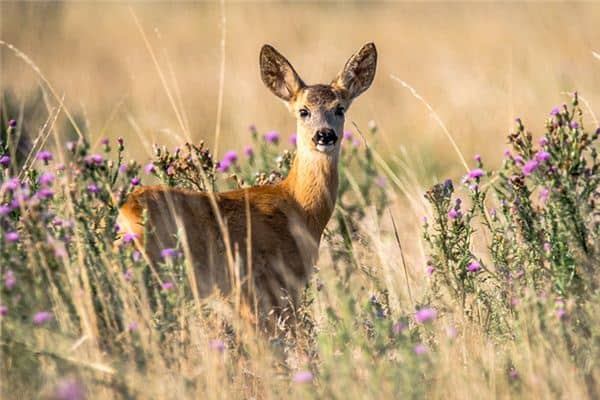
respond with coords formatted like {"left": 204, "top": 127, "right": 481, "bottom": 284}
{"left": 332, "top": 43, "right": 377, "bottom": 99}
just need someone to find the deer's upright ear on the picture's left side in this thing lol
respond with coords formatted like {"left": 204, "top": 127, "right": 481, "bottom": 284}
{"left": 260, "top": 44, "right": 304, "bottom": 102}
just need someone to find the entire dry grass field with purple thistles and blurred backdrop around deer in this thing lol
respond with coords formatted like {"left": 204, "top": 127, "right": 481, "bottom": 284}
{"left": 0, "top": 3, "right": 600, "bottom": 400}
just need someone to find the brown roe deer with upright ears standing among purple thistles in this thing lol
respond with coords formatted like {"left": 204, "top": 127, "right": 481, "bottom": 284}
{"left": 119, "top": 43, "right": 377, "bottom": 332}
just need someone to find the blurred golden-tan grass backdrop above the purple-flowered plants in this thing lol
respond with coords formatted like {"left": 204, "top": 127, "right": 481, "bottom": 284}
{"left": 0, "top": 2, "right": 600, "bottom": 175}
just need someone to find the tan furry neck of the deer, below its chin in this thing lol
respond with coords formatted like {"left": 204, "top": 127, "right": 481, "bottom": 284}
{"left": 284, "top": 146, "right": 339, "bottom": 239}
